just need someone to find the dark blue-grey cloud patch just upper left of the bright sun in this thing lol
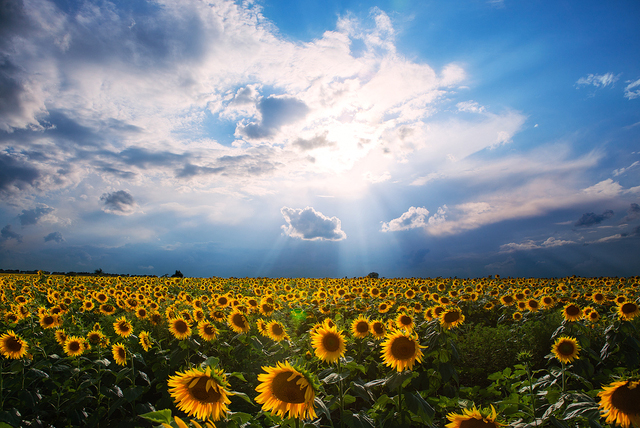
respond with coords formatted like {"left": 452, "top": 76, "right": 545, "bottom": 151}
{"left": 236, "top": 97, "right": 309, "bottom": 139}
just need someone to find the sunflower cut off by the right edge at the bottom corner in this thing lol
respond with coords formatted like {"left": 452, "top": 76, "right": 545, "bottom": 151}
{"left": 598, "top": 380, "right": 640, "bottom": 428}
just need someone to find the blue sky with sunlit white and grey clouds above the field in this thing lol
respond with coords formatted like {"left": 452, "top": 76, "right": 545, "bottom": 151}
{"left": 0, "top": 0, "right": 640, "bottom": 278}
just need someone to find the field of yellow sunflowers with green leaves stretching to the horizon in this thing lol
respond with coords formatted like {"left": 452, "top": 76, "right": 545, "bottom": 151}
{"left": 0, "top": 272, "right": 640, "bottom": 428}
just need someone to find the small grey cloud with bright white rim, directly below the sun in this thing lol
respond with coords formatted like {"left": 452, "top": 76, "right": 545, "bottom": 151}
{"left": 280, "top": 207, "right": 347, "bottom": 241}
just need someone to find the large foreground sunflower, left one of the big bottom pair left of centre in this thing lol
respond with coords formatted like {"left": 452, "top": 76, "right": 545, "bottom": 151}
{"left": 168, "top": 367, "right": 231, "bottom": 421}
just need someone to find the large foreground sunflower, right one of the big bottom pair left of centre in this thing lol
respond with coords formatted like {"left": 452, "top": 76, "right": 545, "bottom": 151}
{"left": 255, "top": 361, "right": 317, "bottom": 419}
